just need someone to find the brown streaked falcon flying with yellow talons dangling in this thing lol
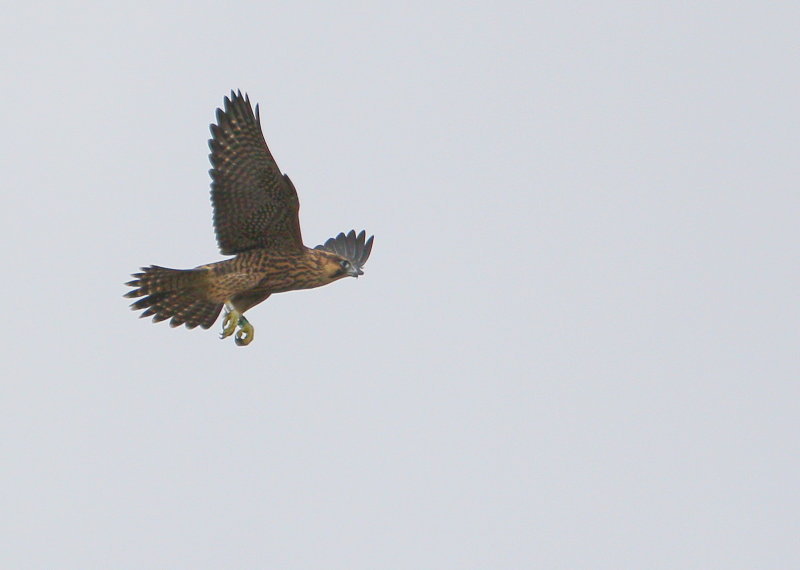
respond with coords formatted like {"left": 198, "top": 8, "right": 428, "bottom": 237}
{"left": 124, "top": 90, "right": 374, "bottom": 346}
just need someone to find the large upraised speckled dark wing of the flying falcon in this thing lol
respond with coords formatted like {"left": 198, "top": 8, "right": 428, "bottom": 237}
{"left": 208, "top": 91, "right": 303, "bottom": 255}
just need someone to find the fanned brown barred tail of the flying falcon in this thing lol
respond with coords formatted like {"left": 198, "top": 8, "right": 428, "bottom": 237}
{"left": 125, "top": 265, "right": 222, "bottom": 329}
